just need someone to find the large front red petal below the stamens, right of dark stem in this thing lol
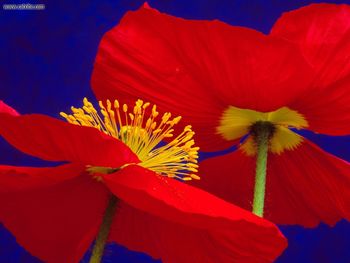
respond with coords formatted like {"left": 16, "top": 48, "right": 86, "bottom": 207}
{"left": 104, "top": 165, "right": 286, "bottom": 263}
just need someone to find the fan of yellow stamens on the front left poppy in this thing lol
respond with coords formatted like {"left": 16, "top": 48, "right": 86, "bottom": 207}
{"left": 60, "top": 98, "right": 199, "bottom": 180}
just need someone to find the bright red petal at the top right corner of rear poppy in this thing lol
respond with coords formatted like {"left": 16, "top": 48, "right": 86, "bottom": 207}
{"left": 271, "top": 4, "right": 350, "bottom": 135}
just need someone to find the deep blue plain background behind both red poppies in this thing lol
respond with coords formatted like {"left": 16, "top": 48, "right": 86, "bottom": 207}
{"left": 0, "top": 0, "right": 350, "bottom": 263}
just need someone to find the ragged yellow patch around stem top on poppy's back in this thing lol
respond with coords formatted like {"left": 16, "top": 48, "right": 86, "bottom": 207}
{"left": 216, "top": 106, "right": 308, "bottom": 156}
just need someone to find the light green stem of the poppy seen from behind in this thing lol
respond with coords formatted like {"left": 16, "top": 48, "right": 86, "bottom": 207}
{"left": 253, "top": 125, "right": 271, "bottom": 217}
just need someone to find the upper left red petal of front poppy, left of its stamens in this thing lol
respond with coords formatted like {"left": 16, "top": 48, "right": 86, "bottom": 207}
{"left": 0, "top": 114, "right": 138, "bottom": 167}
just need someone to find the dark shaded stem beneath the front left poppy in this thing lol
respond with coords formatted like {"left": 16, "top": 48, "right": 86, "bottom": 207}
{"left": 89, "top": 195, "right": 118, "bottom": 263}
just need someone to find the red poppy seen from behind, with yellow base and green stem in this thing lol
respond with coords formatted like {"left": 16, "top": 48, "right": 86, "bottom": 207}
{"left": 92, "top": 4, "right": 350, "bottom": 226}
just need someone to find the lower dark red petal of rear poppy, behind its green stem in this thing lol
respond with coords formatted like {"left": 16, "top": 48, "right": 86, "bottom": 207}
{"left": 199, "top": 141, "right": 350, "bottom": 227}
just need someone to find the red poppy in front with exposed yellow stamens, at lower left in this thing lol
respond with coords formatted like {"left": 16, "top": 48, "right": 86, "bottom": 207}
{"left": 0, "top": 100, "right": 286, "bottom": 263}
